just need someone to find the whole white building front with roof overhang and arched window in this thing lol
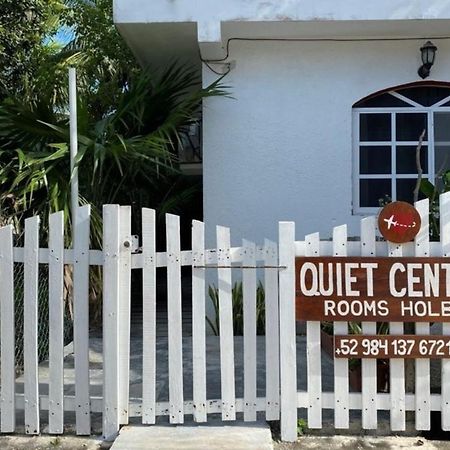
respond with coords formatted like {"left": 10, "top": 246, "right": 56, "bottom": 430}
{"left": 114, "top": 0, "right": 450, "bottom": 244}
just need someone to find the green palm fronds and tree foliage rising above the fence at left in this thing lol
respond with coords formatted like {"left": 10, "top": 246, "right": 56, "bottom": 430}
{"left": 0, "top": 0, "right": 224, "bottom": 246}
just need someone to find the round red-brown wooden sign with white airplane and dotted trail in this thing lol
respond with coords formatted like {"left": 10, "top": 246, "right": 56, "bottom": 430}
{"left": 378, "top": 202, "right": 421, "bottom": 244}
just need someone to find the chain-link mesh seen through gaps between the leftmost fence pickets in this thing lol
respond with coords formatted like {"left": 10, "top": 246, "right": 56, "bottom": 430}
{"left": 14, "top": 263, "right": 73, "bottom": 374}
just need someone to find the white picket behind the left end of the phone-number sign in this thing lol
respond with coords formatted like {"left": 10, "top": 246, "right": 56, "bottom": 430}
{"left": 333, "top": 225, "right": 349, "bottom": 428}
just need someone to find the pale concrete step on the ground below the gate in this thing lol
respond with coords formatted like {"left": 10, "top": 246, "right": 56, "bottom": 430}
{"left": 111, "top": 422, "right": 273, "bottom": 450}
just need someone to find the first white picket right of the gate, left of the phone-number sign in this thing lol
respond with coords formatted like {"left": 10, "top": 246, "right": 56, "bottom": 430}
{"left": 305, "top": 233, "right": 322, "bottom": 428}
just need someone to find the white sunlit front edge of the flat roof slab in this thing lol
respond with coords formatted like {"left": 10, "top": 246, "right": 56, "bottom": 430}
{"left": 114, "top": 0, "right": 450, "bottom": 23}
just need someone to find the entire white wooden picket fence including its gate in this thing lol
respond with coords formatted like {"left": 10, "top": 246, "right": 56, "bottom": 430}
{"left": 0, "top": 194, "right": 450, "bottom": 441}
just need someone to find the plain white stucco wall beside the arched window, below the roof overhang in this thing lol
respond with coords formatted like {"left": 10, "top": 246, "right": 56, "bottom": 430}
{"left": 203, "top": 40, "right": 450, "bottom": 245}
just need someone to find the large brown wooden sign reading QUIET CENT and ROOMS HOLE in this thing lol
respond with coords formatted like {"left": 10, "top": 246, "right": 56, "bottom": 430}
{"left": 296, "top": 257, "right": 450, "bottom": 322}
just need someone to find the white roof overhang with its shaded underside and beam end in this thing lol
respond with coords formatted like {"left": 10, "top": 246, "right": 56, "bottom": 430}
{"left": 114, "top": 0, "right": 450, "bottom": 60}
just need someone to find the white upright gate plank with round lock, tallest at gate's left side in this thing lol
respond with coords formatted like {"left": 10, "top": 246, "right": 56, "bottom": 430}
{"left": 119, "top": 206, "right": 131, "bottom": 425}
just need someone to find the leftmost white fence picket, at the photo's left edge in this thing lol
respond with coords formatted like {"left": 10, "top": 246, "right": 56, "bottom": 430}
{"left": 0, "top": 225, "right": 16, "bottom": 433}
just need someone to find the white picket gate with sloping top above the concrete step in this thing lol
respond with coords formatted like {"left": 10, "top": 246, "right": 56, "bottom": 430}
{"left": 103, "top": 205, "right": 284, "bottom": 438}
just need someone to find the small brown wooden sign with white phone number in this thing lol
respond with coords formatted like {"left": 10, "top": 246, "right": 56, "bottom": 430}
{"left": 334, "top": 335, "right": 450, "bottom": 359}
